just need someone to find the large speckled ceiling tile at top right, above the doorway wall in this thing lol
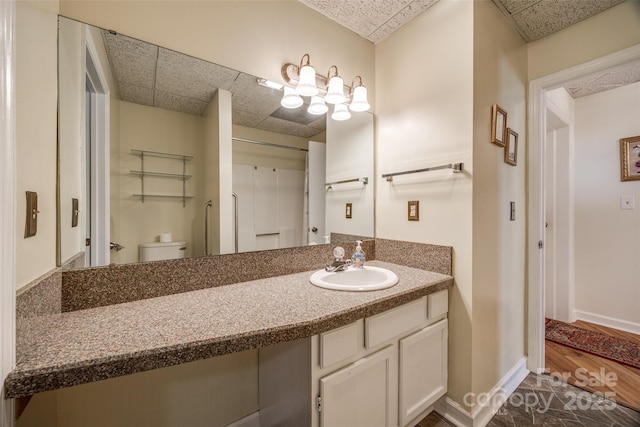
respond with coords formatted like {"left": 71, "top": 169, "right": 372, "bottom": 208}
{"left": 512, "top": 0, "right": 623, "bottom": 41}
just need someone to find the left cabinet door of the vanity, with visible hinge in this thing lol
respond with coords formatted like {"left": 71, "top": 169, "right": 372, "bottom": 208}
{"left": 320, "top": 345, "right": 398, "bottom": 427}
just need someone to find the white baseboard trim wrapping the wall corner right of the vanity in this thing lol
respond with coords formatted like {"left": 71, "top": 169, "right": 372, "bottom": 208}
{"left": 435, "top": 357, "right": 529, "bottom": 427}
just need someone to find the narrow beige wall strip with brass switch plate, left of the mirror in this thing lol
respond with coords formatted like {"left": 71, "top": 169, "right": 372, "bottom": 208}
{"left": 15, "top": 1, "right": 58, "bottom": 288}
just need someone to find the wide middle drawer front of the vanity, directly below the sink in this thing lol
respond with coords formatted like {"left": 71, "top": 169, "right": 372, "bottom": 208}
{"left": 364, "top": 297, "right": 427, "bottom": 348}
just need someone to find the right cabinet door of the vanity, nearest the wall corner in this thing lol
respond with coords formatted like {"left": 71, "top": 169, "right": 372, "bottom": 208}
{"left": 399, "top": 319, "right": 447, "bottom": 426}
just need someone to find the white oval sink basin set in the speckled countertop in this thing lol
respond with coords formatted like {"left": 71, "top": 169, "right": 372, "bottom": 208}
{"left": 309, "top": 265, "right": 398, "bottom": 291}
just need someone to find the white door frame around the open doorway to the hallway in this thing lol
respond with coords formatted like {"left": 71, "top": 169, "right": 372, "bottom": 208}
{"left": 527, "top": 45, "right": 640, "bottom": 373}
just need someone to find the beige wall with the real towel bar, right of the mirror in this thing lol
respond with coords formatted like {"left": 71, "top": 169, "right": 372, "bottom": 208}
{"left": 376, "top": 0, "right": 474, "bottom": 408}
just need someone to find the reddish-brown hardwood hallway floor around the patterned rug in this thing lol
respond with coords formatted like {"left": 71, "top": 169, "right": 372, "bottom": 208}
{"left": 545, "top": 320, "right": 640, "bottom": 411}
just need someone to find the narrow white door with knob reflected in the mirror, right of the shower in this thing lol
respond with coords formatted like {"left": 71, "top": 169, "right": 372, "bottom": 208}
{"left": 307, "top": 141, "right": 328, "bottom": 244}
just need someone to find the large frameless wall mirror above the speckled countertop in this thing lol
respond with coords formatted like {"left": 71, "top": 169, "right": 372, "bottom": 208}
{"left": 58, "top": 17, "right": 374, "bottom": 268}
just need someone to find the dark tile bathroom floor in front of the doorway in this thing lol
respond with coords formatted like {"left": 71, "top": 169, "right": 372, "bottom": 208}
{"left": 416, "top": 374, "right": 640, "bottom": 427}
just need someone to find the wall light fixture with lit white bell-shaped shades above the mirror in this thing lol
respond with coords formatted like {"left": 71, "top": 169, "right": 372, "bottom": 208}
{"left": 281, "top": 53, "right": 371, "bottom": 120}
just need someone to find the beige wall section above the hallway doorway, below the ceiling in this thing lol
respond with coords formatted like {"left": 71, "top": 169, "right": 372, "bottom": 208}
{"left": 528, "top": 0, "right": 640, "bottom": 80}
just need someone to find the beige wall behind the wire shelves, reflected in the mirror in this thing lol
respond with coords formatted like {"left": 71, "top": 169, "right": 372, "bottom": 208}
{"left": 116, "top": 101, "right": 205, "bottom": 262}
